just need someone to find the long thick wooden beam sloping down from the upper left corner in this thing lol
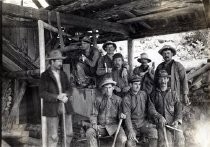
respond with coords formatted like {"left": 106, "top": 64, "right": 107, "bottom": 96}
{"left": 2, "top": 3, "right": 129, "bottom": 36}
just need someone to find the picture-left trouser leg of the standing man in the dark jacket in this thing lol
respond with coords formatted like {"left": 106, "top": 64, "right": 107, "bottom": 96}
{"left": 47, "top": 117, "right": 59, "bottom": 147}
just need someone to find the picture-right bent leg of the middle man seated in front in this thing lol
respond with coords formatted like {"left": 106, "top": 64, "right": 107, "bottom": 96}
{"left": 140, "top": 123, "right": 158, "bottom": 147}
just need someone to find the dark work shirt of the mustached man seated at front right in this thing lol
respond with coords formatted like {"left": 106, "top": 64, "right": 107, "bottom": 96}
{"left": 151, "top": 88, "right": 182, "bottom": 125}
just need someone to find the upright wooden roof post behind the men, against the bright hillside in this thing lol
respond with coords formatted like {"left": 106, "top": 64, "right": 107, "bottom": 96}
{"left": 128, "top": 38, "right": 134, "bottom": 73}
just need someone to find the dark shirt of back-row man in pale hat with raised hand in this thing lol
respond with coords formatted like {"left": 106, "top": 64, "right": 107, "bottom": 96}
{"left": 133, "top": 65, "right": 154, "bottom": 94}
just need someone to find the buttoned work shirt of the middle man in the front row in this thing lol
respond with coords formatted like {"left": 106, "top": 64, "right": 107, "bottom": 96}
{"left": 122, "top": 91, "right": 157, "bottom": 130}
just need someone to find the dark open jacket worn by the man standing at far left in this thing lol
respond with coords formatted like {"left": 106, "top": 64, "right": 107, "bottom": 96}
{"left": 39, "top": 68, "right": 73, "bottom": 117}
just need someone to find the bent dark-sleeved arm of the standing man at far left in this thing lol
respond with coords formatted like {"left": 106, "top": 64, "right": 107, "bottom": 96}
{"left": 39, "top": 73, "right": 58, "bottom": 102}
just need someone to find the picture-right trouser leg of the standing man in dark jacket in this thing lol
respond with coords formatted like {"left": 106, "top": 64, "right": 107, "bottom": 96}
{"left": 66, "top": 115, "right": 73, "bottom": 147}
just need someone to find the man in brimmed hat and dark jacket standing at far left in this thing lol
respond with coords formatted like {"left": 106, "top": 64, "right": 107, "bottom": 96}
{"left": 39, "top": 50, "right": 73, "bottom": 147}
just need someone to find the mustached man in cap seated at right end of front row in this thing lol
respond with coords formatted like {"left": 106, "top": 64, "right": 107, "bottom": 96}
{"left": 151, "top": 70, "right": 184, "bottom": 147}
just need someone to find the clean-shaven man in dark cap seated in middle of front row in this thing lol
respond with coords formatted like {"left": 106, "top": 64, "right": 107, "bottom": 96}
{"left": 122, "top": 76, "right": 158, "bottom": 147}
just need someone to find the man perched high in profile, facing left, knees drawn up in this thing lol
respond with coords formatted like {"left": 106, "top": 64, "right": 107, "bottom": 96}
{"left": 76, "top": 36, "right": 100, "bottom": 87}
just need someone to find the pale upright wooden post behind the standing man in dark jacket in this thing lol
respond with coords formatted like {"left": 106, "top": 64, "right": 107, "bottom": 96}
{"left": 38, "top": 20, "right": 47, "bottom": 147}
